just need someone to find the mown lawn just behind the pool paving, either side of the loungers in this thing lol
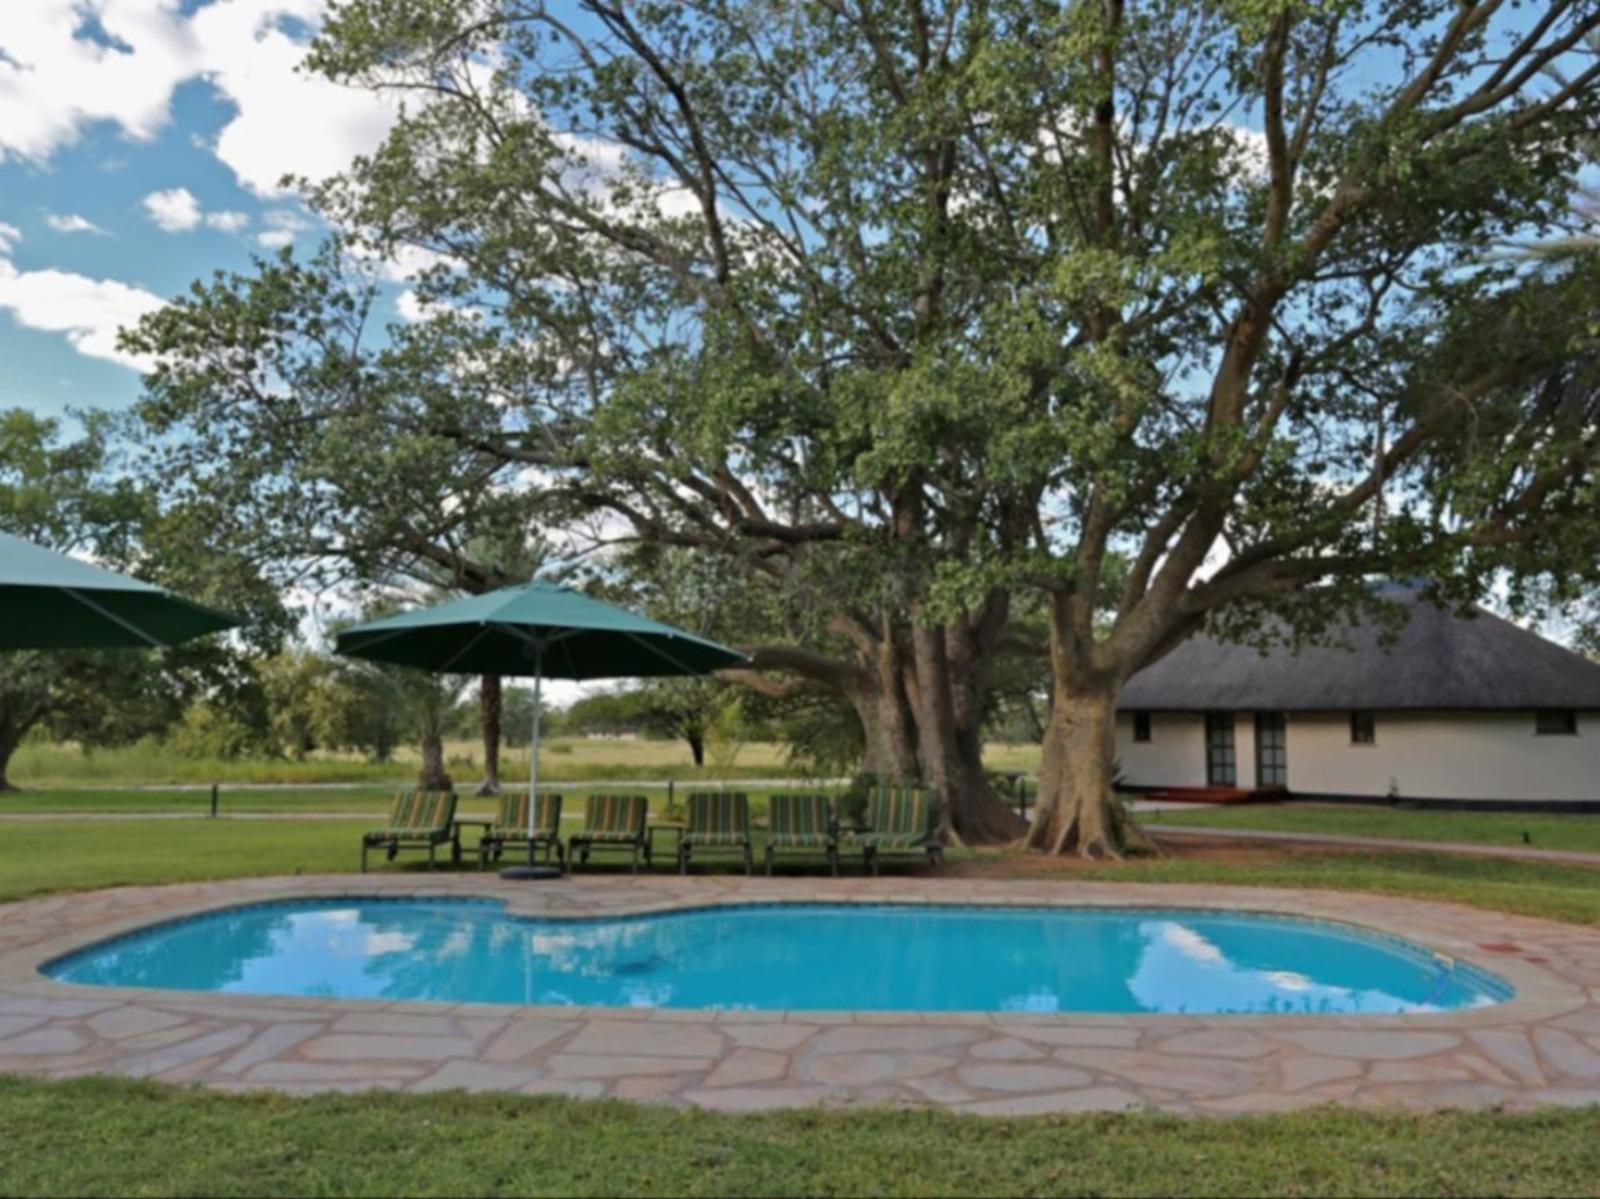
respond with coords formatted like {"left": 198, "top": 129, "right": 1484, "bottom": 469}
{"left": 0, "top": 820, "right": 1600, "bottom": 924}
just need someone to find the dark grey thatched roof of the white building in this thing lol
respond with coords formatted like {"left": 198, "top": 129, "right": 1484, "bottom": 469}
{"left": 1118, "top": 591, "right": 1600, "bottom": 712}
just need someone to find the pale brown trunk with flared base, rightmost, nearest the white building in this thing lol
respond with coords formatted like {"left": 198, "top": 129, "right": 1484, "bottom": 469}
{"left": 1027, "top": 680, "right": 1125, "bottom": 858}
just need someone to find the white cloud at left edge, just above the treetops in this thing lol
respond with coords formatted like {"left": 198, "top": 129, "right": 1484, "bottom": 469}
{"left": 0, "top": 251, "right": 165, "bottom": 370}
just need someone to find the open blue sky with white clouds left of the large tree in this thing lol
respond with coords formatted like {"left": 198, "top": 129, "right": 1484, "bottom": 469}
{"left": 0, "top": 0, "right": 406, "bottom": 416}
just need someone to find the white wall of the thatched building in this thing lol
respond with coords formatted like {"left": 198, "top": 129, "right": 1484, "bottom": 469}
{"left": 1117, "top": 712, "right": 1600, "bottom": 800}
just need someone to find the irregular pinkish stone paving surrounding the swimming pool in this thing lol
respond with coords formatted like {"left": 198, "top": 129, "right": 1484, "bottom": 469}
{"left": 0, "top": 874, "right": 1600, "bottom": 1114}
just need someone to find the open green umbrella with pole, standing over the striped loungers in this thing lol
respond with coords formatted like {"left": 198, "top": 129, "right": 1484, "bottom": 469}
{"left": 334, "top": 583, "right": 749, "bottom": 836}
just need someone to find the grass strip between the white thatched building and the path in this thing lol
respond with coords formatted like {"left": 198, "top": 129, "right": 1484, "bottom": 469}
{"left": 1146, "top": 804, "right": 1600, "bottom": 853}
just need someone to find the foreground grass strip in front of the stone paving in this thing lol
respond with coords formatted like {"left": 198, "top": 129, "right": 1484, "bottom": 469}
{"left": 0, "top": 1077, "right": 1600, "bottom": 1196}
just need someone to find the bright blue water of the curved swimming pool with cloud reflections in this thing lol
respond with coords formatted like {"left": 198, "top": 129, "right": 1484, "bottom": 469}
{"left": 46, "top": 900, "right": 1510, "bottom": 1013}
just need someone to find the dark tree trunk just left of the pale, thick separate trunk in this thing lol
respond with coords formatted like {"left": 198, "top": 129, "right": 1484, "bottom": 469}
{"left": 914, "top": 628, "right": 1026, "bottom": 845}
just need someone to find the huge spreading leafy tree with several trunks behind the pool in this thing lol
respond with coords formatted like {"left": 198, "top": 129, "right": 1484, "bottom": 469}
{"left": 131, "top": 0, "right": 1600, "bottom": 853}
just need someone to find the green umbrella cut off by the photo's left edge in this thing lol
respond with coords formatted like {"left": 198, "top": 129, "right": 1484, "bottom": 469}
{"left": 0, "top": 533, "right": 238, "bottom": 650}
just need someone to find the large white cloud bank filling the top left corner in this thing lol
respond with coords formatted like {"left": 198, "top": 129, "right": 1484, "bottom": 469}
{"left": 0, "top": 0, "right": 397, "bottom": 195}
